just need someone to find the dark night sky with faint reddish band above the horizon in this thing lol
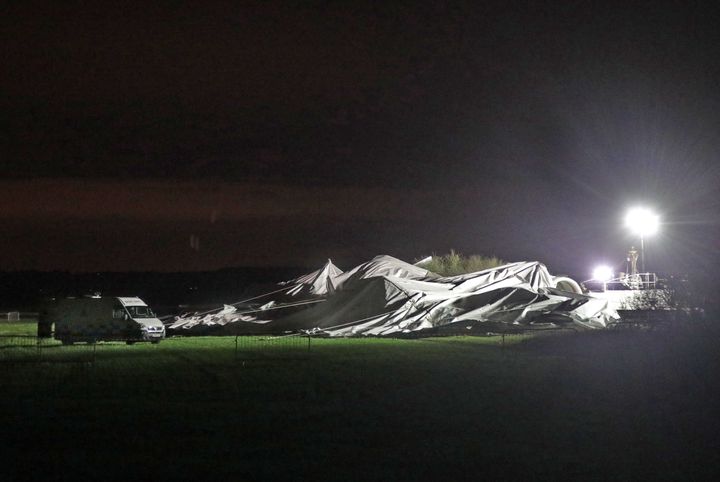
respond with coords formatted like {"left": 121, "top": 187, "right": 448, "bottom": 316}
{"left": 0, "top": 1, "right": 720, "bottom": 279}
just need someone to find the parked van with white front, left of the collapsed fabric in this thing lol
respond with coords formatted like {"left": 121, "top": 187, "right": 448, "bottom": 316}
{"left": 45, "top": 297, "right": 165, "bottom": 345}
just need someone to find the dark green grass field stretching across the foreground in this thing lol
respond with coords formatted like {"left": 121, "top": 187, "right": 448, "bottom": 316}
{"left": 0, "top": 326, "right": 720, "bottom": 480}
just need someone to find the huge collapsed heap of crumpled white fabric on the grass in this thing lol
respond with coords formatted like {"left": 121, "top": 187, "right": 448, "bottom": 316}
{"left": 169, "top": 255, "right": 619, "bottom": 336}
